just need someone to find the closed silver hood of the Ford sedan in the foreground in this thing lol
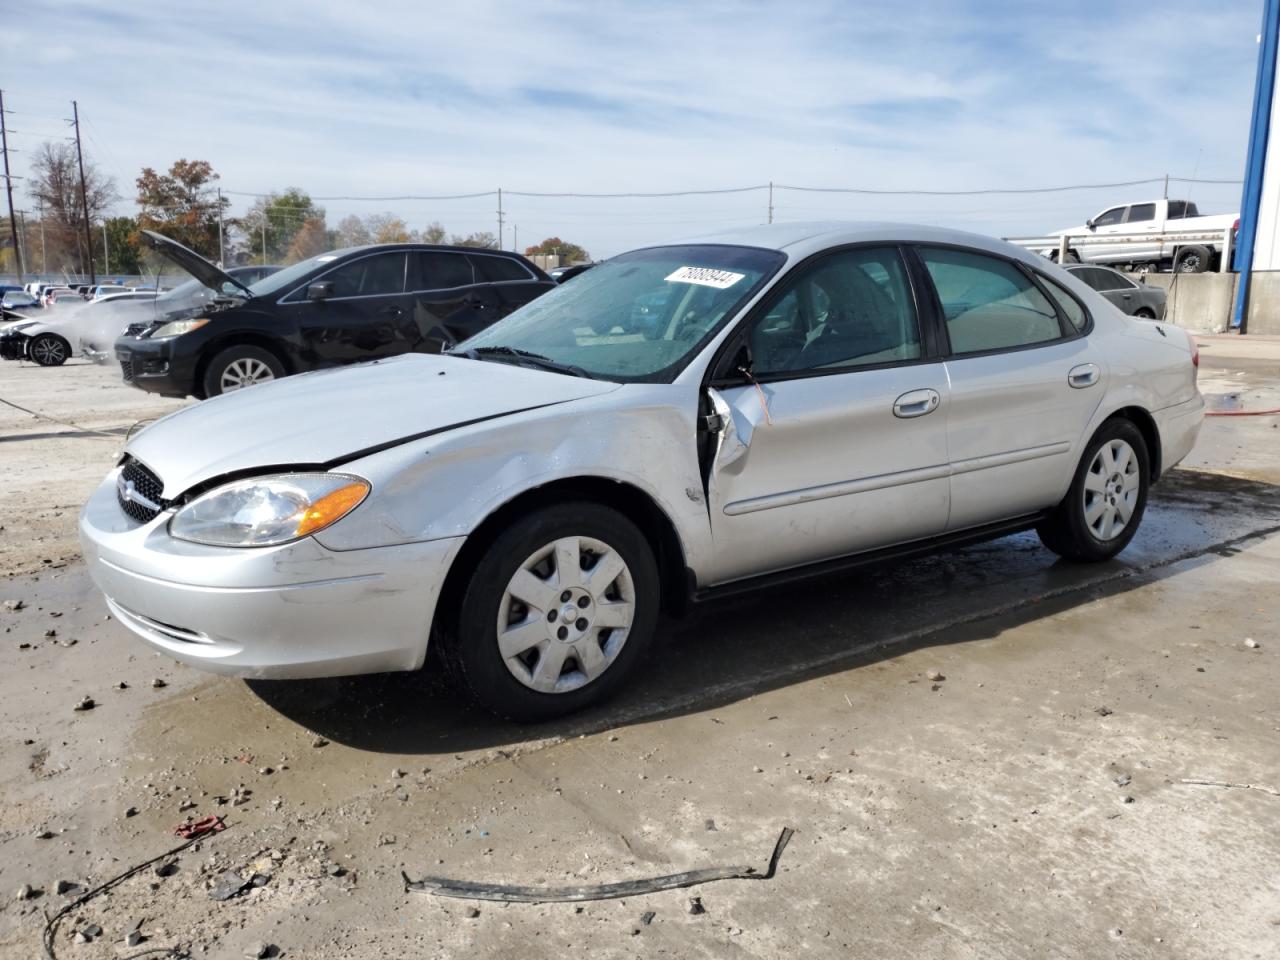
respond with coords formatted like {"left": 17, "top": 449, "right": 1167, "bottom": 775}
{"left": 125, "top": 353, "right": 618, "bottom": 499}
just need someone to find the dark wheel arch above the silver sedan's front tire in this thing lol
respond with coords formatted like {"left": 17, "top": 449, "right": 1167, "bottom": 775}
{"left": 435, "top": 476, "right": 690, "bottom": 634}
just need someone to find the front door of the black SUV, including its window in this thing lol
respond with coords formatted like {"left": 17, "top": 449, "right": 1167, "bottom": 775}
{"left": 291, "top": 251, "right": 410, "bottom": 366}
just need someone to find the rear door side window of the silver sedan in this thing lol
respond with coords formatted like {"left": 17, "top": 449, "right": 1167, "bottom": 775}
{"left": 920, "top": 247, "right": 1062, "bottom": 353}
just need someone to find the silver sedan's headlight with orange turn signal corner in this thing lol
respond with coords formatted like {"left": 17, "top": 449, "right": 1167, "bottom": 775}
{"left": 169, "top": 474, "right": 369, "bottom": 547}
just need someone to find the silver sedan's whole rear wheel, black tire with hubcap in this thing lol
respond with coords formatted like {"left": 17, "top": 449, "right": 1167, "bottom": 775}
{"left": 1036, "top": 419, "right": 1151, "bottom": 563}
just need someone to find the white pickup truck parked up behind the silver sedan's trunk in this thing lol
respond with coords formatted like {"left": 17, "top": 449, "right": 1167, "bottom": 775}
{"left": 1041, "top": 200, "right": 1240, "bottom": 274}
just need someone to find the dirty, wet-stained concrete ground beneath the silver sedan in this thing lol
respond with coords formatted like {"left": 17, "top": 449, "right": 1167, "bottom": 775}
{"left": 0, "top": 338, "right": 1280, "bottom": 960}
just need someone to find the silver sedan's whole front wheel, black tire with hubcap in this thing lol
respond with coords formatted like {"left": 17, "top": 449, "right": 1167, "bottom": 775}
{"left": 439, "top": 502, "right": 659, "bottom": 722}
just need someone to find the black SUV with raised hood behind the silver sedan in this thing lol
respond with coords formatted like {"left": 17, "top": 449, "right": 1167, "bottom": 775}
{"left": 115, "top": 230, "right": 556, "bottom": 398}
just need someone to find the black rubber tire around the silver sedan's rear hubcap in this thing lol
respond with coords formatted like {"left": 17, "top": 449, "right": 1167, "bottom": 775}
{"left": 1036, "top": 417, "right": 1151, "bottom": 563}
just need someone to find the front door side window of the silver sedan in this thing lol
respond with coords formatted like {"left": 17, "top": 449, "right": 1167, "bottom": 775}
{"left": 750, "top": 247, "right": 920, "bottom": 376}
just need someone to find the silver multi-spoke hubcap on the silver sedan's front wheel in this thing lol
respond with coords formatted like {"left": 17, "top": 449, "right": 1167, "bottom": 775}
{"left": 498, "top": 536, "right": 635, "bottom": 694}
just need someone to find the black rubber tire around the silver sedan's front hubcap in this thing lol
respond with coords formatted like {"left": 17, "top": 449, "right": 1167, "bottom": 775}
{"left": 436, "top": 502, "right": 660, "bottom": 722}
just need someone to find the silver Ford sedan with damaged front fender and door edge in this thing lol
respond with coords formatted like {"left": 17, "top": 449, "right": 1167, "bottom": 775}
{"left": 79, "top": 224, "right": 1204, "bottom": 719}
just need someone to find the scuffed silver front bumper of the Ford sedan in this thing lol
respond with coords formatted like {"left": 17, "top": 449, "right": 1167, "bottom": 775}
{"left": 79, "top": 471, "right": 465, "bottom": 678}
